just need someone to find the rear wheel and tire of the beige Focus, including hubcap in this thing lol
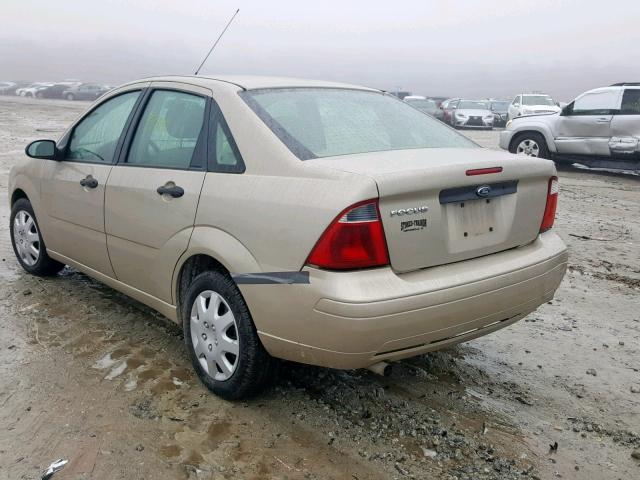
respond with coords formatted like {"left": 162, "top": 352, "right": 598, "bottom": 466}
{"left": 181, "top": 271, "right": 276, "bottom": 400}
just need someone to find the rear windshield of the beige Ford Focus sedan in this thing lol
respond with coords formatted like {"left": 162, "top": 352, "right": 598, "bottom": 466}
{"left": 240, "top": 88, "right": 477, "bottom": 160}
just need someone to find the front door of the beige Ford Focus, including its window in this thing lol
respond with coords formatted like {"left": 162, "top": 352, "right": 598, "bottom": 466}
{"left": 41, "top": 90, "right": 141, "bottom": 276}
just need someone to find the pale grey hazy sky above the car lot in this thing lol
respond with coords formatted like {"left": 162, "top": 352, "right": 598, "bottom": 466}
{"left": 0, "top": 0, "right": 640, "bottom": 100}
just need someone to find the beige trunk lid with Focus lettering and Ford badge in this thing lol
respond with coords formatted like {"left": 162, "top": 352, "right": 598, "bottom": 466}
{"left": 308, "top": 148, "right": 555, "bottom": 272}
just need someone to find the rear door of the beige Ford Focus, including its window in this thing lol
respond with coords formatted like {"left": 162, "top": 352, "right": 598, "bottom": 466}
{"left": 105, "top": 82, "right": 211, "bottom": 302}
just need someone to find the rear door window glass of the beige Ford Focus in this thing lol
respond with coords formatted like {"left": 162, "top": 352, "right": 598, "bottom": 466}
{"left": 126, "top": 90, "right": 206, "bottom": 169}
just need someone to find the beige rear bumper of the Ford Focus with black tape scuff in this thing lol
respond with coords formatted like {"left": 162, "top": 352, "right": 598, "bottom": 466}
{"left": 241, "top": 232, "right": 567, "bottom": 368}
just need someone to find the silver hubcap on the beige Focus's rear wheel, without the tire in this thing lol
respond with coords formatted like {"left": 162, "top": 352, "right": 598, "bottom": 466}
{"left": 191, "top": 290, "right": 240, "bottom": 381}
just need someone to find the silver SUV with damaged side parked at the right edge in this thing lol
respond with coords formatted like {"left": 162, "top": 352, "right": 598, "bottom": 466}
{"left": 500, "top": 83, "right": 640, "bottom": 169}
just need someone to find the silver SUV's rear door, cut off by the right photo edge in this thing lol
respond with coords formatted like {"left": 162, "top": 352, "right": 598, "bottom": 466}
{"left": 610, "top": 88, "right": 640, "bottom": 155}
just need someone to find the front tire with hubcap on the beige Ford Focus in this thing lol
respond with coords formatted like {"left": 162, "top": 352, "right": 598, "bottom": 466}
{"left": 9, "top": 198, "right": 64, "bottom": 276}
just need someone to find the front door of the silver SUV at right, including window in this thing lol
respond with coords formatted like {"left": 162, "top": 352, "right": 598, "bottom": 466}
{"left": 554, "top": 89, "right": 621, "bottom": 156}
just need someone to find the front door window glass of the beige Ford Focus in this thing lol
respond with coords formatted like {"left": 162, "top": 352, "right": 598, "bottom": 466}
{"left": 66, "top": 91, "right": 140, "bottom": 163}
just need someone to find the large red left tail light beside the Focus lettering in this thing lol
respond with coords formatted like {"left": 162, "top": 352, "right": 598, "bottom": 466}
{"left": 307, "top": 200, "right": 389, "bottom": 270}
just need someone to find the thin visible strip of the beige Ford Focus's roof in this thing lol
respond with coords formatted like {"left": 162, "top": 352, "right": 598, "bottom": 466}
{"left": 125, "top": 75, "right": 380, "bottom": 91}
